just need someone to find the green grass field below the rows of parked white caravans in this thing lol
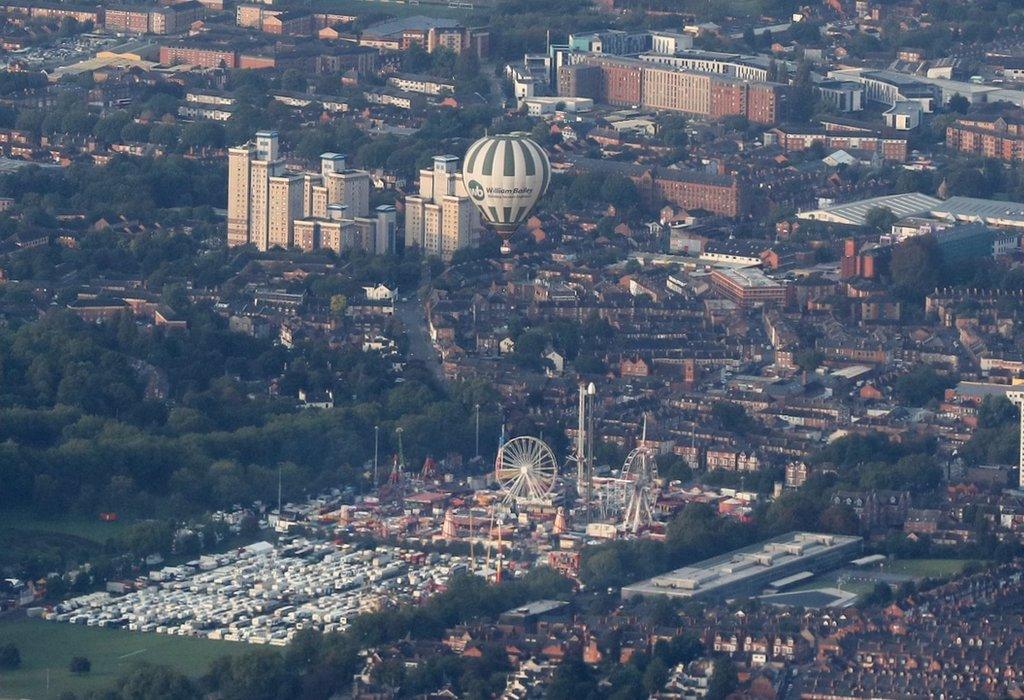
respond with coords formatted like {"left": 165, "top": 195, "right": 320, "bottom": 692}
{"left": 0, "top": 618, "right": 246, "bottom": 700}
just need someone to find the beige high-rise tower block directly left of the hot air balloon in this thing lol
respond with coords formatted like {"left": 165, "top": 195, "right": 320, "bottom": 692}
{"left": 406, "top": 156, "right": 480, "bottom": 260}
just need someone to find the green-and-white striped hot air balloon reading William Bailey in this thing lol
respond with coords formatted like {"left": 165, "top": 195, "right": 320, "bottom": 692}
{"left": 462, "top": 131, "right": 551, "bottom": 253}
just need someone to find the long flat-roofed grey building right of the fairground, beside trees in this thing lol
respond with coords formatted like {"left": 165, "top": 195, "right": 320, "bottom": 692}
{"left": 623, "top": 532, "right": 863, "bottom": 599}
